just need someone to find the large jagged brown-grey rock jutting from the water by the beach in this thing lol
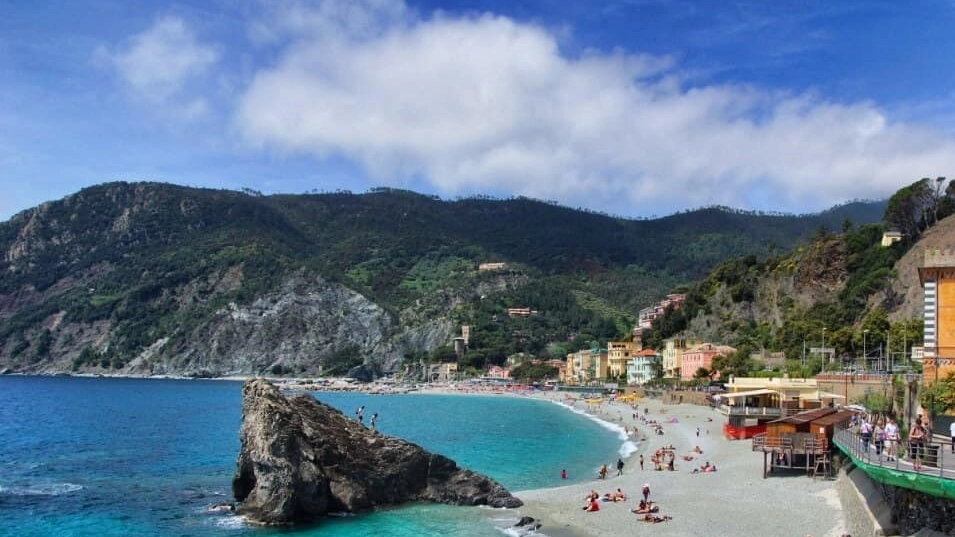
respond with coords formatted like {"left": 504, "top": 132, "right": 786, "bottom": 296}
{"left": 232, "top": 379, "right": 522, "bottom": 525}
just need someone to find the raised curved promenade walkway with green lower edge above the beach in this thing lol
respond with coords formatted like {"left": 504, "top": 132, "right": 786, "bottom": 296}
{"left": 833, "top": 427, "right": 955, "bottom": 500}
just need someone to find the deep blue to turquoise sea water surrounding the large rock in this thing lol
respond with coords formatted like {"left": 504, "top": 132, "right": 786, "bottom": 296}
{"left": 0, "top": 376, "right": 635, "bottom": 537}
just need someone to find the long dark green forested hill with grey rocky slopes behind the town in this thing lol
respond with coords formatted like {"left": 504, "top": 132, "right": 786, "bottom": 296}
{"left": 0, "top": 183, "right": 885, "bottom": 374}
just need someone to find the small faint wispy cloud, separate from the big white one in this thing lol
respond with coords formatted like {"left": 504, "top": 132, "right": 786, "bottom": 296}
{"left": 98, "top": 17, "right": 219, "bottom": 104}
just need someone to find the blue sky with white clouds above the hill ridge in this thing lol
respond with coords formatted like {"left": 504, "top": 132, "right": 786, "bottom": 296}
{"left": 0, "top": 0, "right": 955, "bottom": 220}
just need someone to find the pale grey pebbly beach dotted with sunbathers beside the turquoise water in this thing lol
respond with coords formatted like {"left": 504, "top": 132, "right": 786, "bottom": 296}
{"left": 516, "top": 392, "right": 846, "bottom": 537}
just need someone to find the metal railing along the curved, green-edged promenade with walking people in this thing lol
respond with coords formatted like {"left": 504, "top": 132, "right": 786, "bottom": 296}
{"left": 833, "top": 424, "right": 955, "bottom": 479}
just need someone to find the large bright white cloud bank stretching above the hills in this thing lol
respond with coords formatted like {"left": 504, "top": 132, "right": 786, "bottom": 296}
{"left": 235, "top": 0, "right": 955, "bottom": 214}
